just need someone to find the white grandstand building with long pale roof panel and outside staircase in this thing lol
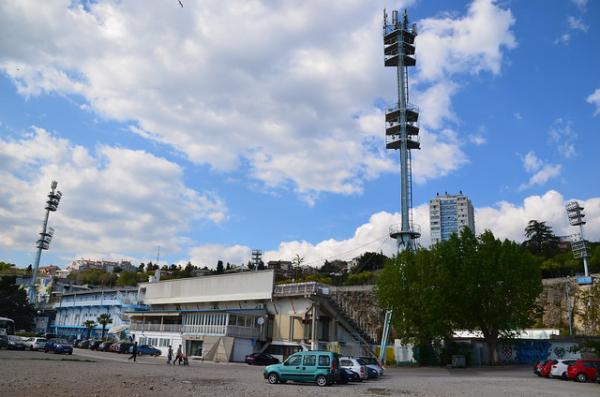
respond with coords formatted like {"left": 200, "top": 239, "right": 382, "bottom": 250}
{"left": 128, "top": 270, "right": 370, "bottom": 362}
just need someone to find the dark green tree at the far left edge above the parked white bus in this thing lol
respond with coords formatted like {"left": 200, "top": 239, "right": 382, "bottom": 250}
{"left": 0, "top": 276, "right": 35, "bottom": 331}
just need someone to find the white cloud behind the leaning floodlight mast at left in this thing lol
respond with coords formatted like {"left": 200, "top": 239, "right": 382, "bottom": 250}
{"left": 0, "top": 127, "right": 227, "bottom": 257}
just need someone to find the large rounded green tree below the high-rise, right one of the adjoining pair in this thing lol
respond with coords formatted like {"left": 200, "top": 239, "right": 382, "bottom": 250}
{"left": 446, "top": 228, "right": 542, "bottom": 363}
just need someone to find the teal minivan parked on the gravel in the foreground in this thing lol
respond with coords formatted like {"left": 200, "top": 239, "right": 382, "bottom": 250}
{"left": 263, "top": 350, "right": 340, "bottom": 386}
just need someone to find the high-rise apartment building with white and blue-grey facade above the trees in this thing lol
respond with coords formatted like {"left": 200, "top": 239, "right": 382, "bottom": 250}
{"left": 429, "top": 191, "right": 475, "bottom": 244}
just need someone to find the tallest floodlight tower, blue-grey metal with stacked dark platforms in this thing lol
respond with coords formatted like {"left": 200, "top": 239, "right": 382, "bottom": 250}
{"left": 383, "top": 10, "right": 421, "bottom": 252}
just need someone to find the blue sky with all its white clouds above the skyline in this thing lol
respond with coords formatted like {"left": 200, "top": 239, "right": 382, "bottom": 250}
{"left": 0, "top": 0, "right": 600, "bottom": 267}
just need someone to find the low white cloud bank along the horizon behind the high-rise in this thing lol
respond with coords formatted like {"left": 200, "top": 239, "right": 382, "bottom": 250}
{"left": 190, "top": 190, "right": 600, "bottom": 266}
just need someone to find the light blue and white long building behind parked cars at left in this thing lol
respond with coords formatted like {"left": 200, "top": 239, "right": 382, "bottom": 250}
{"left": 48, "top": 287, "right": 143, "bottom": 339}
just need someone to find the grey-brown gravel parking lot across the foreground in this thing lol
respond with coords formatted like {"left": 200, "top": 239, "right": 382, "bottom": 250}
{"left": 0, "top": 349, "right": 600, "bottom": 397}
